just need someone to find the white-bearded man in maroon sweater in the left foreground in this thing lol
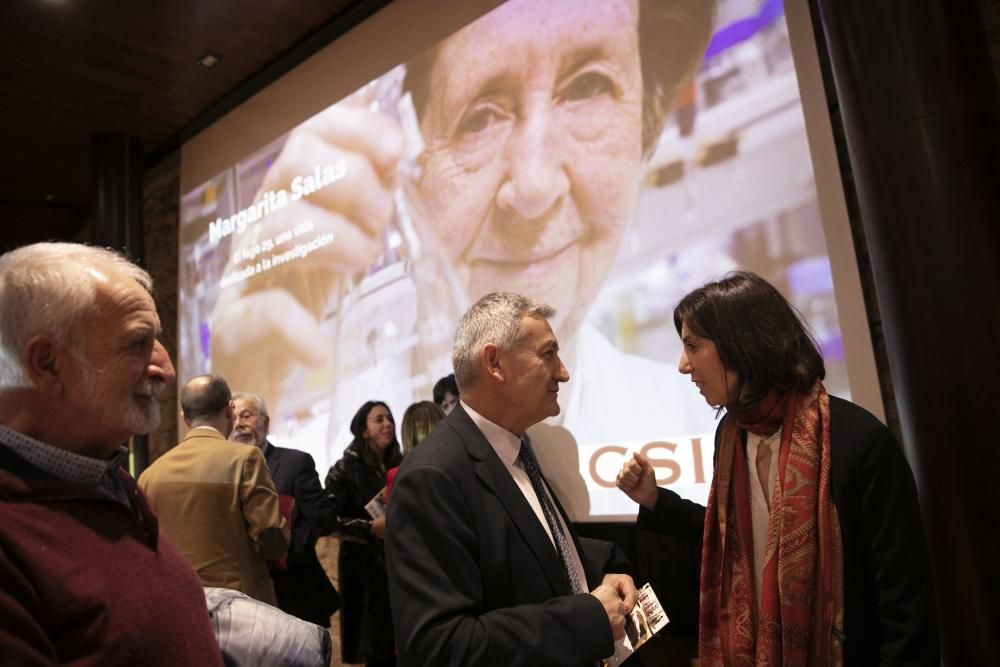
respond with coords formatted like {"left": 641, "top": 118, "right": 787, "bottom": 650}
{"left": 0, "top": 243, "right": 222, "bottom": 665}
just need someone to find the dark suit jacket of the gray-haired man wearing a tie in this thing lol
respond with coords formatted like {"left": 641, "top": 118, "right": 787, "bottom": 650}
{"left": 386, "top": 405, "right": 627, "bottom": 667}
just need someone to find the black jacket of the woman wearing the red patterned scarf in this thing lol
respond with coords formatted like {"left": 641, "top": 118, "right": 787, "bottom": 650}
{"left": 637, "top": 396, "right": 941, "bottom": 666}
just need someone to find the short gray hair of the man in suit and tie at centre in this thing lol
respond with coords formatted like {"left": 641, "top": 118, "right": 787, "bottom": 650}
{"left": 451, "top": 292, "right": 556, "bottom": 392}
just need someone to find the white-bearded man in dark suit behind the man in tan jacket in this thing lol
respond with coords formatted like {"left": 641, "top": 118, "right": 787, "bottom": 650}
{"left": 230, "top": 392, "right": 341, "bottom": 627}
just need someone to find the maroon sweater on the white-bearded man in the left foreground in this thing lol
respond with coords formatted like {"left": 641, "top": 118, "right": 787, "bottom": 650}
{"left": 0, "top": 445, "right": 222, "bottom": 667}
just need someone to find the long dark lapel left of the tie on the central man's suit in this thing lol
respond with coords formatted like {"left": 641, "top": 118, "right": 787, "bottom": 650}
{"left": 447, "top": 405, "right": 571, "bottom": 595}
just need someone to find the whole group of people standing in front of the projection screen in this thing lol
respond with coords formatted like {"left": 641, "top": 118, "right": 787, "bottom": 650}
{"left": 0, "top": 243, "right": 939, "bottom": 666}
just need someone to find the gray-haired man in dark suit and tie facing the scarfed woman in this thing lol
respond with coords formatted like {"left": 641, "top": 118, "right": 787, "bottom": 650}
{"left": 386, "top": 293, "right": 636, "bottom": 667}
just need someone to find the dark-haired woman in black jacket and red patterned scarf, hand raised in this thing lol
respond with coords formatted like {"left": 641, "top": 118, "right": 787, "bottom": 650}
{"left": 617, "top": 272, "right": 940, "bottom": 667}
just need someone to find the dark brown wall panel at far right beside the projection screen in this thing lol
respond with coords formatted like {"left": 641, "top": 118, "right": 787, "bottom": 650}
{"left": 814, "top": 0, "right": 1000, "bottom": 665}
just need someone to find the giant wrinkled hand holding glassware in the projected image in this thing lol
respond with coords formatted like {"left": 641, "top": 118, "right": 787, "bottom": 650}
{"left": 212, "top": 103, "right": 403, "bottom": 400}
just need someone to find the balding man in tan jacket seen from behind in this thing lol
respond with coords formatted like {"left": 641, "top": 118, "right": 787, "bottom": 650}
{"left": 139, "top": 375, "right": 289, "bottom": 606}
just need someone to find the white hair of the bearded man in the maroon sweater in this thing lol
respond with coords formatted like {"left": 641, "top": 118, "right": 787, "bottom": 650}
{"left": 0, "top": 243, "right": 153, "bottom": 388}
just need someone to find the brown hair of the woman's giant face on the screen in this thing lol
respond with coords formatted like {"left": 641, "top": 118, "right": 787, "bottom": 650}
{"left": 403, "top": 0, "right": 715, "bottom": 157}
